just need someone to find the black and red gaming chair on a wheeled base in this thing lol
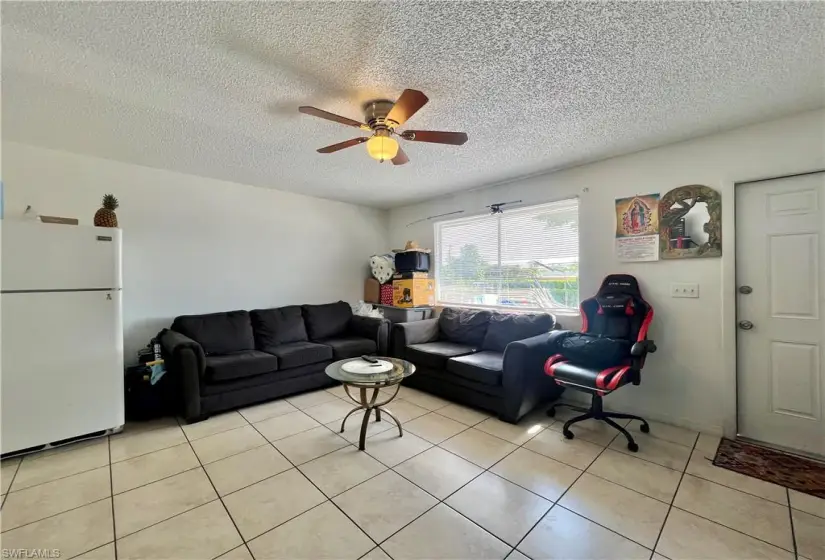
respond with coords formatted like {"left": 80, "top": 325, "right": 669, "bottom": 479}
{"left": 544, "top": 274, "right": 656, "bottom": 452}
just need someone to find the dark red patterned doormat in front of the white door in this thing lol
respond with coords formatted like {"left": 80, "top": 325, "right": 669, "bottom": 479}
{"left": 713, "top": 438, "right": 825, "bottom": 498}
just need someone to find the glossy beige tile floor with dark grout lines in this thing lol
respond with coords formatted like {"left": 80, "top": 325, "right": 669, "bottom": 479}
{"left": 0, "top": 388, "right": 825, "bottom": 560}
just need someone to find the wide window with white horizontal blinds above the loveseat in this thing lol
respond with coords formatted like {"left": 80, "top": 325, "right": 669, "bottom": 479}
{"left": 435, "top": 198, "right": 579, "bottom": 312}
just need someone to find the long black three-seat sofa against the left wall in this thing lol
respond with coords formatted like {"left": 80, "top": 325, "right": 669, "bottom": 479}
{"left": 165, "top": 301, "right": 389, "bottom": 422}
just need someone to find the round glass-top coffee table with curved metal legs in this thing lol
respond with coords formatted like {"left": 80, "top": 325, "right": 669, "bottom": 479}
{"left": 326, "top": 356, "right": 415, "bottom": 451}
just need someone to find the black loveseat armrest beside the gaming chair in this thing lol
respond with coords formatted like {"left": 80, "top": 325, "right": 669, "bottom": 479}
{"left": 501, "top": 331, "right": 563, "bottom": 422}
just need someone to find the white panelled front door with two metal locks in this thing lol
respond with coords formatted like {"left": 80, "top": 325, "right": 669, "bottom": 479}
{"left": 736, "top": 173, "right": 825, "bottom": 455}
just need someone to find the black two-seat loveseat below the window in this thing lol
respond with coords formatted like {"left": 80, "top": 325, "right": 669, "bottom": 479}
{"left": 391, "top": 307, "right": 563, "bottom": 423}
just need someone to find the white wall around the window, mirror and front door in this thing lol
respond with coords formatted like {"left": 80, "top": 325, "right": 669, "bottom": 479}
{"left": 390, "top": 110, "right": 825, "bottom": 432}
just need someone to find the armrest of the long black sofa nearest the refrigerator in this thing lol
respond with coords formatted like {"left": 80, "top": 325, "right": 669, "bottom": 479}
{"left": 159, "top": 329, "right": 206, "bottom": 420}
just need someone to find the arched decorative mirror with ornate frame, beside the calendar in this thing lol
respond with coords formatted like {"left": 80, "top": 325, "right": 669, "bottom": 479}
{"left": 659, "top": 185, "right": 722, "bottom": 259}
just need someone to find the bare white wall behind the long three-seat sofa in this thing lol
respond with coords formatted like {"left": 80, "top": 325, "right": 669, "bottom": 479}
{"left": 3, "top": 142, "right": 389, "bottom": 363}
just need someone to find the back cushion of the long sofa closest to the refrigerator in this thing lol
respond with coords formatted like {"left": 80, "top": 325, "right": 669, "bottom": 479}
{"left": 172, "top": 311, "right": 255, "bottom": 356}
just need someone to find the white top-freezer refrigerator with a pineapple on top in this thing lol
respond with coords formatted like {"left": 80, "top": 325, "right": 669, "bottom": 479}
{"left": 0, "top": 220, "right": 124, "bottom": 454}
